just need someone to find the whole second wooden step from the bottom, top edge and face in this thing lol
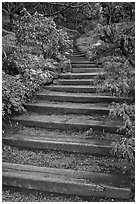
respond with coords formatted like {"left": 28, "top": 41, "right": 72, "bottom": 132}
{"left": 2, "top": 134, "right": 114, "bottom": 157}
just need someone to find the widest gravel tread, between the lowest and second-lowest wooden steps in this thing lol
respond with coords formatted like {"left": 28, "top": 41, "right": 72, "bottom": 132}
{"left": 3, "top": 145, "right": 131, "bottom": 174}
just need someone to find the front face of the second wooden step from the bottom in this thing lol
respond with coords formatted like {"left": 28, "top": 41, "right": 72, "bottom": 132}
{"left": 3, "top": 139, "right": 114, "bottom": 156}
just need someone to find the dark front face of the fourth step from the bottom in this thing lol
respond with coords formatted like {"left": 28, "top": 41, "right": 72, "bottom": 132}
{"left": 25, "top": 104, "right": 109, "bottom": 115}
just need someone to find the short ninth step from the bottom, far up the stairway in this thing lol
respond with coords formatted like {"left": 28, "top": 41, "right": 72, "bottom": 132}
{"left": 72, "top": 67, "right": 103, "bottom": 73}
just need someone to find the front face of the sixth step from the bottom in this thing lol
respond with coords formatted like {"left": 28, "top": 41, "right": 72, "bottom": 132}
{"left": 45, "top": 86, "right": 96, "bottom": 93}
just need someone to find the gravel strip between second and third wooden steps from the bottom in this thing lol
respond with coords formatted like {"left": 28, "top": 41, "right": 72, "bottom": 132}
{"left": 3, "top": 126, "right": 123, "bottom": 141}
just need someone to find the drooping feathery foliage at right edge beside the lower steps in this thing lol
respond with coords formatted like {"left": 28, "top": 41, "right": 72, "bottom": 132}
{"left": 109, "top": 103, "right": 135, "bottom": 171}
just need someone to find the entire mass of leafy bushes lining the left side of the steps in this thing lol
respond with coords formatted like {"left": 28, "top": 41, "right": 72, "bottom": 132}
{"left": 2, "top": 10, "right": 71, "bottom": 118}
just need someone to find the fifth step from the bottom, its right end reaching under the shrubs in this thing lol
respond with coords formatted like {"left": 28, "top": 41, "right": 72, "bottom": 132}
{"left": 36, "top": 90, "right": 133, "bottom": 103}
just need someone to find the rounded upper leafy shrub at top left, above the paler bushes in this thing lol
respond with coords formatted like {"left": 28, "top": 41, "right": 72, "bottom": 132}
{"left": 14, "top": 9, "right": 71, "bottom": 58}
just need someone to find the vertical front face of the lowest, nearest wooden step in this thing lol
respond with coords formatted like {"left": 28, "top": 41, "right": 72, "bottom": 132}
{"left": 2, "top": 173, "right": 130, "bottom": 199}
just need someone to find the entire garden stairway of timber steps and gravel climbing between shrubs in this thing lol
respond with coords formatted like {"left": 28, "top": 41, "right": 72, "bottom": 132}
{"left": 3, "top": 39, "right": 131, "bottom": 202}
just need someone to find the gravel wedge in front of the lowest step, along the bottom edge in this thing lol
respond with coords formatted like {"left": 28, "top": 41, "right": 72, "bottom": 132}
{"left": 2, "top": 186, "right": 128, "bottom": 202}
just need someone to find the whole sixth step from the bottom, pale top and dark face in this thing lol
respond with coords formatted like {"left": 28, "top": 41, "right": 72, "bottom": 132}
{"left": 43, "top": 85, "right": 96, "bottom": 93}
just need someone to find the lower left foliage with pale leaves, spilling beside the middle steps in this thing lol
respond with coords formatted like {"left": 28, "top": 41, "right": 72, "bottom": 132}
{"left": 2, "top": 69, "right": 53, "bottom": 118}
